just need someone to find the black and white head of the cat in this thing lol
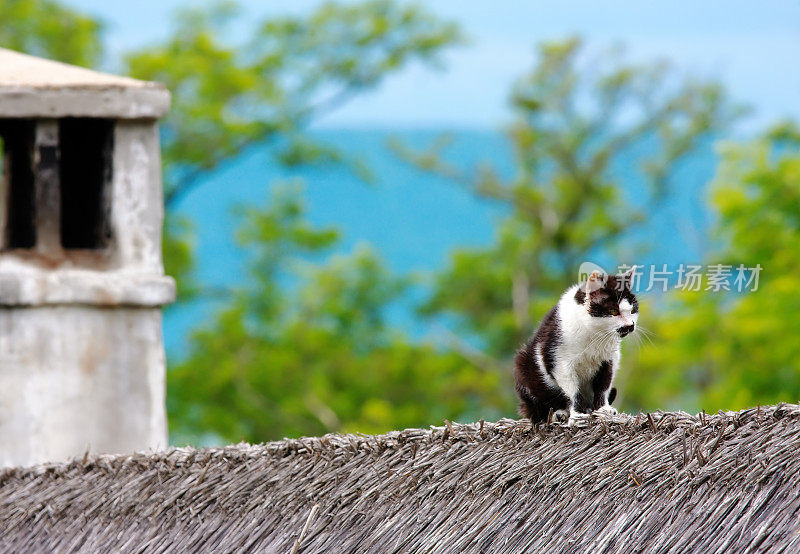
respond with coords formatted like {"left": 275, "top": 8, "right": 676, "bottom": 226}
{"left": 575, "top": 266, "right": 639, "bottom": 337}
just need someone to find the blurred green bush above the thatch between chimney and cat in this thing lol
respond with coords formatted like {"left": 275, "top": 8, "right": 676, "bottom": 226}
{"left": 168, "top": 186, "right": 509, "bottom": 442}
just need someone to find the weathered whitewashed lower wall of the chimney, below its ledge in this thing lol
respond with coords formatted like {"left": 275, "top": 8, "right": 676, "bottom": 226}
{"left": 0, "top": 306, "right": 167, "bottom": 466}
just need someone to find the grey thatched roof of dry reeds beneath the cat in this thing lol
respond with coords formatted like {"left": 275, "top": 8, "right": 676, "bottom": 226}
{"left": 0, "top": 405, "right": 800, "bottom": 553}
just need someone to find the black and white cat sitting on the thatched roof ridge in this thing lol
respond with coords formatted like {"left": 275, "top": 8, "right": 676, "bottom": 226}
{"left": 514, "top": 266, "right": 639, "bottom": 422}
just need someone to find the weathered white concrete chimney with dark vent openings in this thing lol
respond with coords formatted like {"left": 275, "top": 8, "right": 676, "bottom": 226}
{"left": 0, "top": 49, "right": 175, "bottom": 466}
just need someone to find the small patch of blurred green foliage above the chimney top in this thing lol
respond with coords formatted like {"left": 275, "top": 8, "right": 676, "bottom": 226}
{"left": 0, "top": 0, "right": 103, "bottom": 67}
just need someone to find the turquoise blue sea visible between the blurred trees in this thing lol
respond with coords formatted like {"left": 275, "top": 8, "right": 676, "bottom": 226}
{"left": 164, "top": 129, "right": 716, "bottom": 360}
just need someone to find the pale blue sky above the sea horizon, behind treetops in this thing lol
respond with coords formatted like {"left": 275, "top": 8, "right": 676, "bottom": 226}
{"left": 65, "top": 0, "right": 800, "bottom": 129}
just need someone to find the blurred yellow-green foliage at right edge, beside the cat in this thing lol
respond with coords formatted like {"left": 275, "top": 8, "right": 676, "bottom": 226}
{"left": 625, "top": 124, "right": 800, "bottom": 411}
